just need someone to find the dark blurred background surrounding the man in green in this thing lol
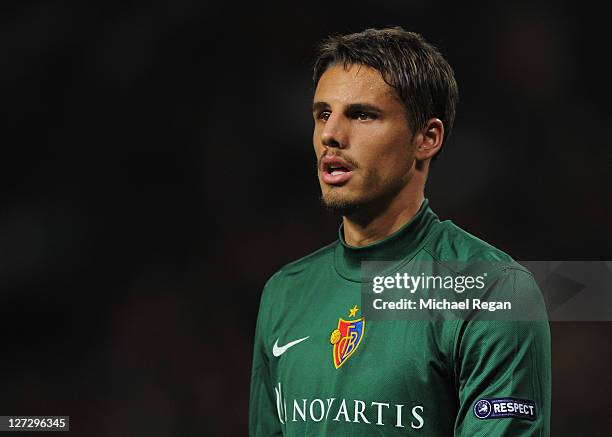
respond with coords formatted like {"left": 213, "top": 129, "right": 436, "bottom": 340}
{"left": 0, "top": 0, "right": 612, "bottom": 436}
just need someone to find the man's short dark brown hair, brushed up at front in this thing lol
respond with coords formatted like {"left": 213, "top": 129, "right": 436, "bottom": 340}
{"left": 313, "top": 26, "right": 459, "bottom": 149}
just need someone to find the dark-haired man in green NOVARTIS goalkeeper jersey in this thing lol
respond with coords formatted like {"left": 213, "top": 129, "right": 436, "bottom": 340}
{"left": 250, "top": 28, "right": 550, "bottom": 436}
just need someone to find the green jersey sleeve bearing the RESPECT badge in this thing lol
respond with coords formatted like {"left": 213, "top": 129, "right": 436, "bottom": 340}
{"left": 455, "top": 269, "right": 551, "bottom": 437}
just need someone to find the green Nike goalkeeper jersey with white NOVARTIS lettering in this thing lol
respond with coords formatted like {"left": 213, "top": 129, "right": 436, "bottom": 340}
{"left": 249, "top": 200, "right": 550, "bottom": 437}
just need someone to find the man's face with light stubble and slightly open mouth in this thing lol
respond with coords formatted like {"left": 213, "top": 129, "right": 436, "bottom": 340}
{"left": 313, "top": 64, "right": 414, "bottom": 215}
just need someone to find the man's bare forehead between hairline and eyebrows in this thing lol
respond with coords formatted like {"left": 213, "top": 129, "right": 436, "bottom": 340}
{"left": 314, "top": 64, "right": 399, "bottom": 105}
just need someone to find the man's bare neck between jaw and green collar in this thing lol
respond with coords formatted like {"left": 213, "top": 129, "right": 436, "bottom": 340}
{"left": 342, "top": 187, "right": 424, "bottom": 247}
